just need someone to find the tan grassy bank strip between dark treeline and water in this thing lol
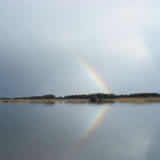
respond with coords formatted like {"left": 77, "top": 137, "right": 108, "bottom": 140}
{"left": 0, "top": 97, "right": 160, "bottom": 103}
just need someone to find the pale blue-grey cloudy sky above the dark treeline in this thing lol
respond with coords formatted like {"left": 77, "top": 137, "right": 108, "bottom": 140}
{"left": 0, "top": 0, "right": 160, "bottom": 97}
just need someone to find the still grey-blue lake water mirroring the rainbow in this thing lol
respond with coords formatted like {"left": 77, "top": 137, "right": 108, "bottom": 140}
{"left": 0, "top": 103, "right": 160, "bottom": 160}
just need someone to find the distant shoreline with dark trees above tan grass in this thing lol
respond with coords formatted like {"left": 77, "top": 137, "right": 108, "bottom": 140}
{"left": 0, "top": 93, "right": 160, "bottom": 103}
